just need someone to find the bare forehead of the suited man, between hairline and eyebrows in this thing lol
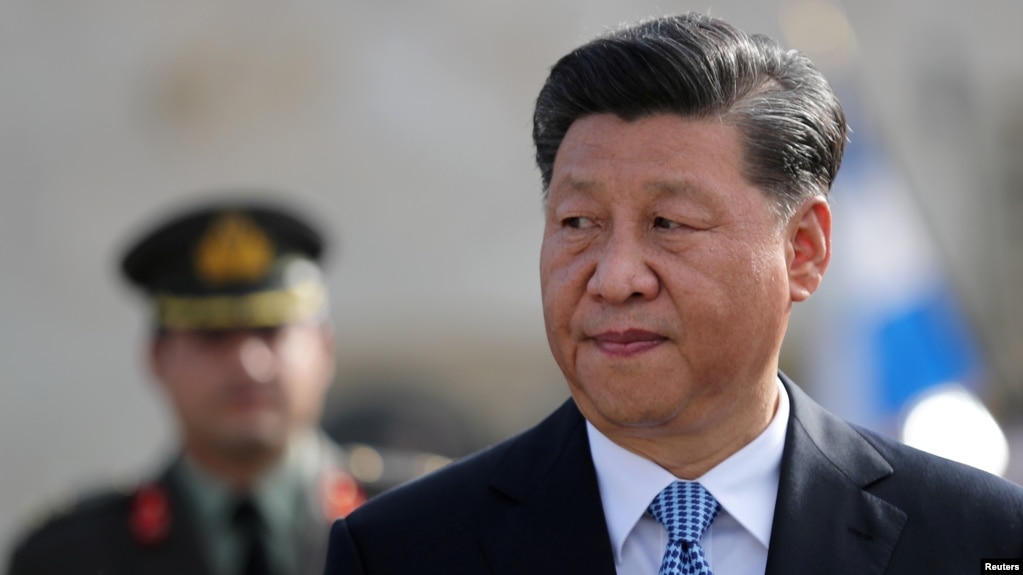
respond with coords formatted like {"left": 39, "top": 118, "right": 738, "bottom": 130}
{"left": 550, "top": 114, "right": 751, "bottom": 201}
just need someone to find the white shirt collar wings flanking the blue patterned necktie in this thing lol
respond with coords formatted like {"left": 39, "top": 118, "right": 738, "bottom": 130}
{"left": 586, "top": 380, "right": 790, "bottom": 561}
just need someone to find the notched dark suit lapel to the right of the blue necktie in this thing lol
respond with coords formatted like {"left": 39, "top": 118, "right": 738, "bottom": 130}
{"left": 766, "top": 375, "right": 906, "bottom": 575}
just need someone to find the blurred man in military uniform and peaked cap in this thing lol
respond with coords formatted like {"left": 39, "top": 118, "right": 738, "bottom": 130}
{"left": 9, "top": 202, "right": 363, "bottom": 575}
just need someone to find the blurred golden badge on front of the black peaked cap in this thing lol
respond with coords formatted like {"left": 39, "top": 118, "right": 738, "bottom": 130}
{"left": 195, "top": 213, "right": 273, "bottom": 284}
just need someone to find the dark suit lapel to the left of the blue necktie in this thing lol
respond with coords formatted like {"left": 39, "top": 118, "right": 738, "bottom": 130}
{"left": 479, "top": 400, "right": 615, "bottom": 575}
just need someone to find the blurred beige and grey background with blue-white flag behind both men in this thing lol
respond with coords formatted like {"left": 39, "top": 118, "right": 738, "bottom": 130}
{"left": 0, "top": 0, "right": 1023, "bottom": 551}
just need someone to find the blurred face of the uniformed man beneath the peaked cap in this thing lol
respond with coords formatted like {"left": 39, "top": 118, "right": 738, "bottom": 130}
{"left": 150, "top": 324, "right": 333, "bottom": 458}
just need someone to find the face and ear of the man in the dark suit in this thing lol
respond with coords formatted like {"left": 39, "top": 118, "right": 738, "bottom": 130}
{"left": 540, "top": 115, "right": 830, "bottom": 436}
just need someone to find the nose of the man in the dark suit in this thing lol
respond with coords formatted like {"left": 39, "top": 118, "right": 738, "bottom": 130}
{"left": 586, "top": 230, "right": 661, "bottom": 304}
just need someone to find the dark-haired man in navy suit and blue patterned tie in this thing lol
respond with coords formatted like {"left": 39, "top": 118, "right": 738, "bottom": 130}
{"left": 326, "top": 14, "right": 1023, "bottom": 575}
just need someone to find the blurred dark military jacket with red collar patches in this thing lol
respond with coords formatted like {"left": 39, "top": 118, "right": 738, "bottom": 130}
{"left": 9, "top": 435, "right": 363, "bottom": 575}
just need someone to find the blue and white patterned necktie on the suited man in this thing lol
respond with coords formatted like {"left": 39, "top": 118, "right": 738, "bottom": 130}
{"left": 649, "top": 481, "right": 721, "bottom": 575}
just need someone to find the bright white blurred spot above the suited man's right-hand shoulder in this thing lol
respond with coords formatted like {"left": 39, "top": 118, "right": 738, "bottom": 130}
{"left": 902, "top": 384, "right": 1009, "bottom": 476}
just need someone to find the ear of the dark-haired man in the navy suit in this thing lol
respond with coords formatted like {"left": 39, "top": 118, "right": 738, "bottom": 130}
{"left": 788, "top": 197, "right": 831, "bottom": 302}
